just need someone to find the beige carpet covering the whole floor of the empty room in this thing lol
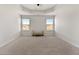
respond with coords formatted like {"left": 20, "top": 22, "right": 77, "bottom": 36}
{"left": 0, "top": 36, "right": 79, "bottom": 55}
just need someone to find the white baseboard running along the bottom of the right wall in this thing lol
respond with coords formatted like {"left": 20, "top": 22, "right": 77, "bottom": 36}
{"left": 56, "top": 33, "right": 79, "bottom": 48}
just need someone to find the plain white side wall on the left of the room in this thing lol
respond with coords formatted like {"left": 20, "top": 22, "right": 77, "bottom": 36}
{"left": 0, "top": 4, "right": 19, "bottom": 46}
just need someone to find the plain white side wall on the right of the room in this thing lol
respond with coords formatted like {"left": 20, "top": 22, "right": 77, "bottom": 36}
{"left": 56, "top": 5, "right": 79, "bottom": 47}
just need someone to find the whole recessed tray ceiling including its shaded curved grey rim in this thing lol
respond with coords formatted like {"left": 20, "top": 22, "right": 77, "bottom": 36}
{"left": 20, "top": 4, "right": 56, "bottom": 14}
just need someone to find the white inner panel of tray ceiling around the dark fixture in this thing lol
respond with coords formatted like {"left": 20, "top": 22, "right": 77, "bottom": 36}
{"left": 23, "top": 4, "right": 55, "bottom": 10}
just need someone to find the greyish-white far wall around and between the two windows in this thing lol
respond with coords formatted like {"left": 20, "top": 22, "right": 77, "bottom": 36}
{"left": 22, "top": 15, "right": 54, "bottom": 35}
